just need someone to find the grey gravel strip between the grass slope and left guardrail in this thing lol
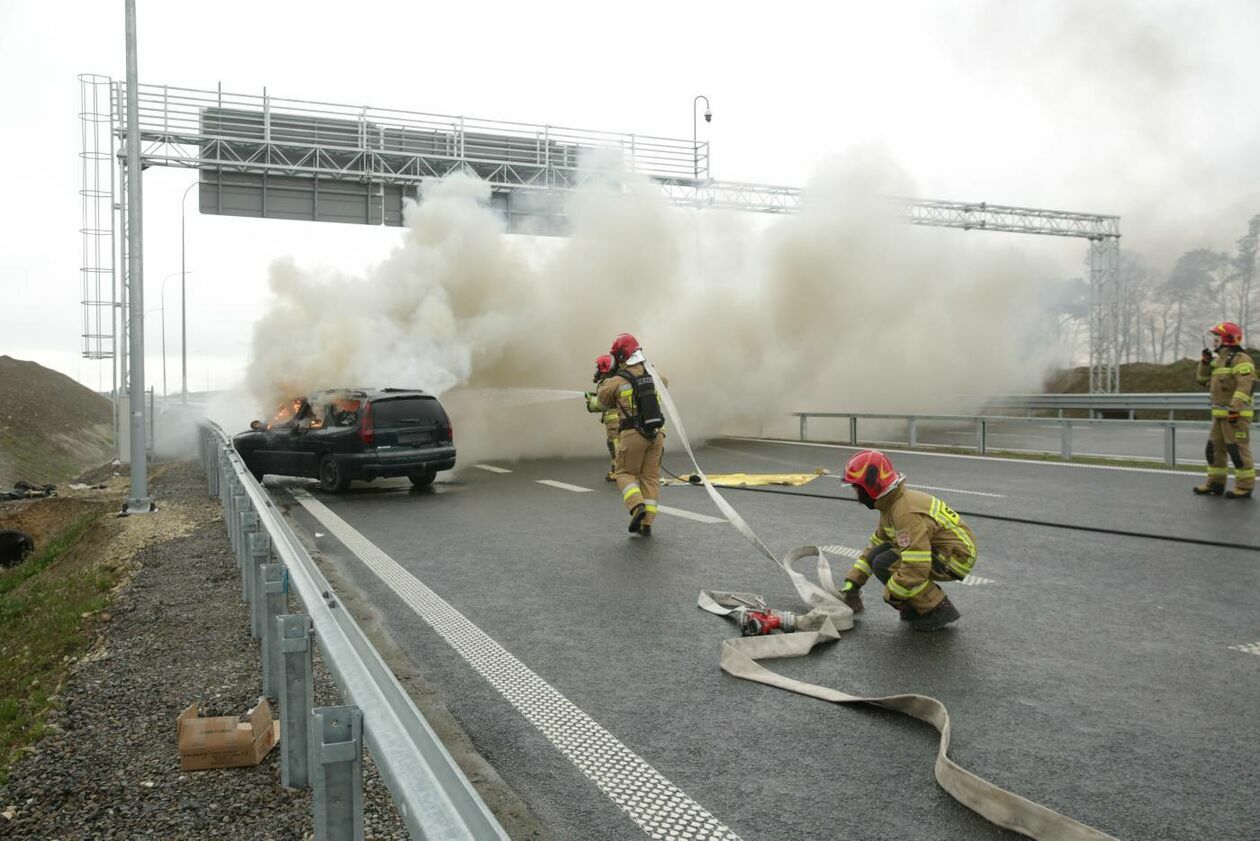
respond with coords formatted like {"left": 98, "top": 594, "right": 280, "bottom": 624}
{"left": 0, "top": 463, "right": 407, "bottom": 841}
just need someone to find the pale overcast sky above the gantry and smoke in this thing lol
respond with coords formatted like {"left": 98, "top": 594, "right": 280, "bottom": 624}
{"left": 0, "top": 0, "right": 1260, "bottom": 391}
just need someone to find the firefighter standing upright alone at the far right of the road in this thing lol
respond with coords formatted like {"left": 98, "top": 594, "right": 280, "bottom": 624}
{"left": 1194, "top": 322, "right": 1256, "bottom": 499}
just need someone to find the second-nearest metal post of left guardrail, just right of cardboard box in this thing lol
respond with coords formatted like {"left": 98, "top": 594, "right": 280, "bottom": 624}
{"left": 276, "top": 614, "right": 315, "bottom": 788}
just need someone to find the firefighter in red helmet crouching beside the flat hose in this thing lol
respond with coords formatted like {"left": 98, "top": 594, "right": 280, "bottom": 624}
{"left": 843, "top": 450, "right": 975, "bottom": 630}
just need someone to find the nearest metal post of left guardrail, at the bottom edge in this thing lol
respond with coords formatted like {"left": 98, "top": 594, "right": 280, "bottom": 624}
{"left": 311, "top": 706, "right": 363, "bottom": 841}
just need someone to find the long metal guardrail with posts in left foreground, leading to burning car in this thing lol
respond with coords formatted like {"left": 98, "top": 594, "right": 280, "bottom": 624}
{"left": 200, "top": 422, "right": 508, "bottom": 841}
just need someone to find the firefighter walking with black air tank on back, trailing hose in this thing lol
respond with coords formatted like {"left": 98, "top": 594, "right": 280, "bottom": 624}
{"left": 596, "top": 333, "right": 669, "bottom": 537}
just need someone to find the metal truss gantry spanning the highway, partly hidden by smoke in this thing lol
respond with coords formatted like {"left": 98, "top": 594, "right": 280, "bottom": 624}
{"left": 78, "top": 77, "right": 1120, "bottom": 392}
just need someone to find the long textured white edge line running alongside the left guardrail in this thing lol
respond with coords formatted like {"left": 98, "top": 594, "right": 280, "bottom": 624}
{"left": 294, "top": 490, "right": 740, "bottom": 841}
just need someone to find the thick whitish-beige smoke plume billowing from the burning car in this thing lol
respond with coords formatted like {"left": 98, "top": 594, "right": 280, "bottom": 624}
{"left": 240, "top": 151, "right": 1053, "bottom": 463}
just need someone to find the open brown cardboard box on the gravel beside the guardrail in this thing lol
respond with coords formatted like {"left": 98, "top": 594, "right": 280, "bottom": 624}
{"left": 175, "top": 697, "right": 280, "bottom": 770}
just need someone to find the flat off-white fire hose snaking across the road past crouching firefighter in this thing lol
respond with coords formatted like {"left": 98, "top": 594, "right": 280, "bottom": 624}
{"left": 648, "top": 363, "right": 1115, "bottom": 841}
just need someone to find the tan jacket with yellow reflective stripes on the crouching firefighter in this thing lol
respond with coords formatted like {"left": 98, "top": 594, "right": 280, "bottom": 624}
{"left": 856, "top": 485, "right": 975, "bottom": 606}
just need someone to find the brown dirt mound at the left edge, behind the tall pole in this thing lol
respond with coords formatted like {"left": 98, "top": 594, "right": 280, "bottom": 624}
{"left": 0, "top": 356, "right": 113, "bottom": 488}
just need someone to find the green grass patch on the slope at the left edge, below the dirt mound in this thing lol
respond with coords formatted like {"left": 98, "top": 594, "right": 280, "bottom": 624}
{"left": 0, "top": 514, "right": 121, "bottom": 783}
